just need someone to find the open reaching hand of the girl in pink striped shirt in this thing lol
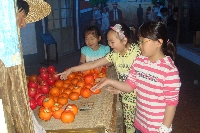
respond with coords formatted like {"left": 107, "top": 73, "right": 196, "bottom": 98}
{"left": 90, "top": 78, "right": 109, "bottom": 91}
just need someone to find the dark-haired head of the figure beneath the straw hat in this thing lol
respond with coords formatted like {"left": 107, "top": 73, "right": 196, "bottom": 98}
{"left": 17, "top": 0, "right": 29, "bottom": 29}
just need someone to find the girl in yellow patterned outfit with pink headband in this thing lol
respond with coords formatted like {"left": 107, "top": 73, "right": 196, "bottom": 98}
{"left": 58, "top": 23, "right": 140, "bottom": 133}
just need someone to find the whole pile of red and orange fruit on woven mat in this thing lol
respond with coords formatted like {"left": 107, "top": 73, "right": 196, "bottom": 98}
{"left": 27, "top": 66, "right": 106, "bottom": 123}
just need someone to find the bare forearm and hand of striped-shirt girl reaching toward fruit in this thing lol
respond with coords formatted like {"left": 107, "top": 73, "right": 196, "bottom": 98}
{"left": 91, "top": 78, "right": 134, "bottom": 92}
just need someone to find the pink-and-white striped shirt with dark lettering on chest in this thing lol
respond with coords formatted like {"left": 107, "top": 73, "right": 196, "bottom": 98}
{"left": 126, "top": 56, "right": 181, "bottom": 133}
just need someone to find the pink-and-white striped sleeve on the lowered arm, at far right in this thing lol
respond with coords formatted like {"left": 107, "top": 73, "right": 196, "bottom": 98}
{"left": 164, "top": 67, "right": 181, "bottom": 106}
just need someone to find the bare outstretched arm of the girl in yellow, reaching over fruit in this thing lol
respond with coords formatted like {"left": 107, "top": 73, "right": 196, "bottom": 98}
{"left": 57, "top": 57, "right": 109, "bottom": 80}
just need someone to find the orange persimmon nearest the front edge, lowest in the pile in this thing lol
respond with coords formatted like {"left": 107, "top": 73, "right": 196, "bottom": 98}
{"left": 61, "top": 110, "right": 75, "bottom": 123}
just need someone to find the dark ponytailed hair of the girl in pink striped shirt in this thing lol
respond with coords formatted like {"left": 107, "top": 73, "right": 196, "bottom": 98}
{"left": 138, "top": 21, "right": 176, "bottom": 60}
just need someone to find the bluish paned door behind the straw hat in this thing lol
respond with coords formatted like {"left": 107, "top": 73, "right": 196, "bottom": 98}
{"left": 47, "top": 0, "right": 75, "bottom": 57}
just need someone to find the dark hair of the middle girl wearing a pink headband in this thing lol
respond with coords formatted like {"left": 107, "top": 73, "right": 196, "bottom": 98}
{"left": 110, "top": 23, "right": 137, "bottom": 44}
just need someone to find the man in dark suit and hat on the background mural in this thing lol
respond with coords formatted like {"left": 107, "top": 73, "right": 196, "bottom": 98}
{"left": 109, "top": 2, "right": 123, "bottom": 25}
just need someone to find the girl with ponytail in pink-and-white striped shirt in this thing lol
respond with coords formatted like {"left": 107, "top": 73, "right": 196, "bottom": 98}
{"left": 91, "top": 22, "right": 181, "bottom": 133}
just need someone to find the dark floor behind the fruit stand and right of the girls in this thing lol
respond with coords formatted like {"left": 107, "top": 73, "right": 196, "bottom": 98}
{"left": 26, "top": 52, "right": 200, "bottom": 133}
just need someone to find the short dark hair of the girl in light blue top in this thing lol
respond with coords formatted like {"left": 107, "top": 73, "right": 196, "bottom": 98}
{"left": 84, "top": 26, "right": 101, "bottom": 38}
